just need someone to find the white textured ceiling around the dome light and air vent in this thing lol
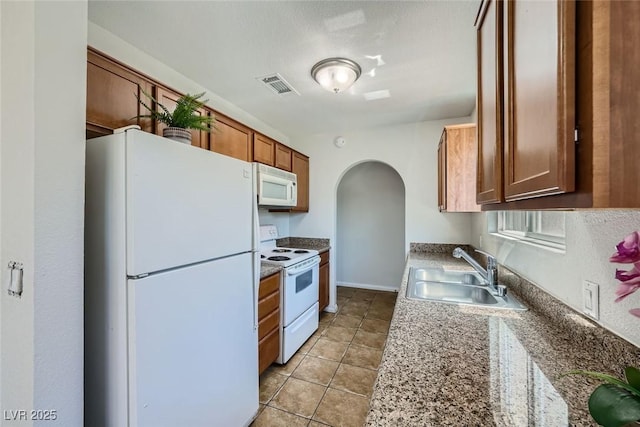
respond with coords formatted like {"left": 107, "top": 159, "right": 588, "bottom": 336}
{"left": 89, "top": 0, "right": 479, "bottom": 137}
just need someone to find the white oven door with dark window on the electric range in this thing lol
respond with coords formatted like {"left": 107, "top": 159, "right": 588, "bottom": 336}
{"left": 282, "top": 256, "right": 320, "bottom": 326}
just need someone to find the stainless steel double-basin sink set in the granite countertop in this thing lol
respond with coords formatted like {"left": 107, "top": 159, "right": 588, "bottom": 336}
{"left": 406, "top": 267, "right": 527, "bottom": 311}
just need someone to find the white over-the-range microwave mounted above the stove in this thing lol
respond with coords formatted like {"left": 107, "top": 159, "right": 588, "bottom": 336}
{"left": 253, "top": 163, "right": 298, "bottom": 206}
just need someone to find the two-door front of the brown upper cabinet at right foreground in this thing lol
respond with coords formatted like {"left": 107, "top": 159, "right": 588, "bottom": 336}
{"left": 477, "top": 0, "right": 575, "bottom": 207}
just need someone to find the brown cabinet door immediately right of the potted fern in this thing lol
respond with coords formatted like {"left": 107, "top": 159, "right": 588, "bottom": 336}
{"left": 209, "top": 114, "right": 253, "bottom": 162}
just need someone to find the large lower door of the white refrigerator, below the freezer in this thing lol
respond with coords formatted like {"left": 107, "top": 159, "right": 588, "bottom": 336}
{"left": 128, "top": 254, "right": 258, "bottom": 427}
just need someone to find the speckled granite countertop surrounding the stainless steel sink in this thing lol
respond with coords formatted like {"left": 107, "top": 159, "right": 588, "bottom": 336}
{"left": 366, "top": 244, "right": 640, "bottom": 427}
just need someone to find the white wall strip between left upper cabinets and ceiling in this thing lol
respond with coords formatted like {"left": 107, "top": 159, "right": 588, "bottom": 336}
{"left": 88, "top": 22, "right": 289, "bottom": 149}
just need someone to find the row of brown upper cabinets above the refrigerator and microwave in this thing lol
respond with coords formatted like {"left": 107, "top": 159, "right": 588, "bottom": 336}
{"left": 86, "top": 47, "right": 309, "bottom": 212}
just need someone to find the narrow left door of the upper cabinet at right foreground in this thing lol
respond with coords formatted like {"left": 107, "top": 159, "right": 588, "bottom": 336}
{"left": 476, "top": 0, "right": 502, "bottom": 204}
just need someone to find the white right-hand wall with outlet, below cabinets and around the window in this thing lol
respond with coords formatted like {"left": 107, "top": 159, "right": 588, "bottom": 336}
{"left": 471, "top": 210, "right": 640, "bottom": 346}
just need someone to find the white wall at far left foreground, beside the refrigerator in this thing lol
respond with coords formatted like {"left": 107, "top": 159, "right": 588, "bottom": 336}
{"left": 0, "top": 1, "right": 87, "bottom": 426}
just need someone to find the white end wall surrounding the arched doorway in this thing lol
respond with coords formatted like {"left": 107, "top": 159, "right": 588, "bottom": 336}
{"left": 289, "top": 117, "right": 471, "bottom": 305}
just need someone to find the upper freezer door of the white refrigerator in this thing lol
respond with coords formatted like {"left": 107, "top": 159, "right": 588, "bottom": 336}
{"left": 126, "top": 131, "right": 254, "bottom": 276}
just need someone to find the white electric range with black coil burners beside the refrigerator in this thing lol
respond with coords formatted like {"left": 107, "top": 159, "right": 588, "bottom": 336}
{"left": 260, "top": 225, "right": 320, "bottom": 363}
